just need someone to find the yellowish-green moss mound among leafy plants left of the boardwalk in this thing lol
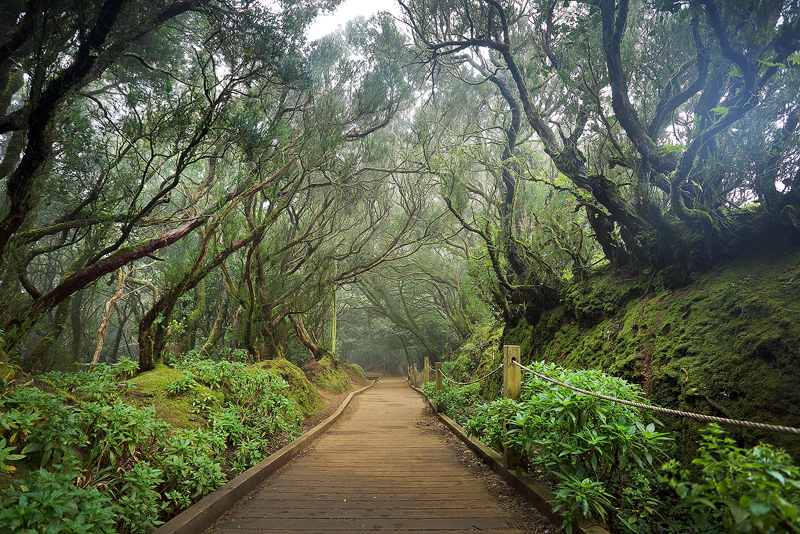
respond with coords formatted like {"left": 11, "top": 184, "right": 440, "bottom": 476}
{"left": 125, "top": 364, "right": 225, "bottom": 428}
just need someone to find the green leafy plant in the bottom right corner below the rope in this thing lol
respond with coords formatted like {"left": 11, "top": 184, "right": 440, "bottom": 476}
{"left": 664, "top": 424, "right": 800, "bottom": 533}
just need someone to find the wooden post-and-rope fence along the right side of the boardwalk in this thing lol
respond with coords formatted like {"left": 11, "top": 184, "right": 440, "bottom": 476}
{"left": 408, "top": 345, "right": 800, "bottom": 436}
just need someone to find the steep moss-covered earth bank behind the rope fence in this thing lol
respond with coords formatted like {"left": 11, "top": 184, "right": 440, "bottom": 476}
{"left": 468, "top": 248, "right": 800, "bottom": 460}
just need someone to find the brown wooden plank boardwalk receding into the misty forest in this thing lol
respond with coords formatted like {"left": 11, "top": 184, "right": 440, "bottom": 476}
{"left": 215, "top": 378, "right": 523, "bottom": 534}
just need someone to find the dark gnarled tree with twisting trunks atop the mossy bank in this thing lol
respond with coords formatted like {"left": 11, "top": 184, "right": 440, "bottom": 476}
{"left": 400, "top": 0, "right": 800, "bottom": 298}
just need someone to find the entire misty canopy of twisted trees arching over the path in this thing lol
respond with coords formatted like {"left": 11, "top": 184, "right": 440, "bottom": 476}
{"left": 0, "top": 0, "right": 800, "bottom": 369}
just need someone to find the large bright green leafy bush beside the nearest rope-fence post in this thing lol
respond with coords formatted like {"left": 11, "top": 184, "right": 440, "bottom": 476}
{"left": 456, "top": 362, "right": 672, "bottom": 530}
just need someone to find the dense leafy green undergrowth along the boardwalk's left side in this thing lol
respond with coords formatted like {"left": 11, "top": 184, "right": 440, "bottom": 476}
{"left": 0, "top": 355, "right": 302, "bottom": 534}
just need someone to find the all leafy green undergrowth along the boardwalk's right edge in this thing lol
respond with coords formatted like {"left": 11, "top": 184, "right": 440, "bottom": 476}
{"left": 423, "top": 362, "right": 800, "bottom": 534}
